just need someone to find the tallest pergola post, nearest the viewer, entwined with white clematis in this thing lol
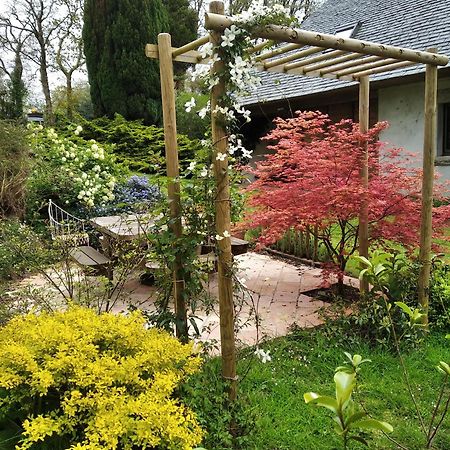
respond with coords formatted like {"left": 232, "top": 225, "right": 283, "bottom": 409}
{"left": 209, "top": 1, "right": 237, "bottom": 401}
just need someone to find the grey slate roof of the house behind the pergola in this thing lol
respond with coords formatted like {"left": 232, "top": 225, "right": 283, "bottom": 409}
{"left": 242, "top": 0, "right": 450, "bottom": 105}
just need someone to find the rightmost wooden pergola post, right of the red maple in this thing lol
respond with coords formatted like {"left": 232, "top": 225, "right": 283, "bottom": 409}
{"left": 418, "top": 48, "right": 437, "bottom": 324}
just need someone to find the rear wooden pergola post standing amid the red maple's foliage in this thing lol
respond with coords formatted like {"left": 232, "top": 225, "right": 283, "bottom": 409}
{"left": 359, "top": 76, "right": 370, "bottom": 294}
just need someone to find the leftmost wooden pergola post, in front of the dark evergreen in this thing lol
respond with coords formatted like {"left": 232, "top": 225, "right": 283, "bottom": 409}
{"left": 158, "top": 33, "right": 188, "bottom": 342}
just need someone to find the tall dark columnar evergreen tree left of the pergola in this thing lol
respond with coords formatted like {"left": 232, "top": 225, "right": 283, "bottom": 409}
{"left": 83, "top": 0, "right": 169, "bottom": 123}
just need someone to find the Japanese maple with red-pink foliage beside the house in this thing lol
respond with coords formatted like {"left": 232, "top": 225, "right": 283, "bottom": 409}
{"left": 246, "top": 112, "right": 450, "bottom": 290}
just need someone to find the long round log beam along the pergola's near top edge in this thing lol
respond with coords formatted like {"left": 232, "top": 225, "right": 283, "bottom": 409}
{"left": 205, "top": 13, "right": 449, "bottom": 66}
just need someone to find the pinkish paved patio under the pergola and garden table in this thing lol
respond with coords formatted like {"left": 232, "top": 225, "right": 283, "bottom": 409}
{"left": 14, "top": 252, "right": 357, "bottom": 345}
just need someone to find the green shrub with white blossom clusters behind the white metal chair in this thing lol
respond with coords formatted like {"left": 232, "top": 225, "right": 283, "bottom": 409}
{"left": 29, "top": 126, "right": 119, "bottom": 213}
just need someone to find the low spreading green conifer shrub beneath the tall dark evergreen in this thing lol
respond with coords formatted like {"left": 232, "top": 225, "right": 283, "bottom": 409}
{"left": 81, "top": 114, "right": 201, "bottom": 175}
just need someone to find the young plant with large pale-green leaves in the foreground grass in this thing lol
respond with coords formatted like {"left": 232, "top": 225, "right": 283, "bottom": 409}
{"left": 303, "top": 353, "right": 393, "bottom": 449}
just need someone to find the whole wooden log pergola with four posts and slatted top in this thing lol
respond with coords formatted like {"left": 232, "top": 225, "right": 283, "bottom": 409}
{"left": 146, "top": 1, "right": 449, "bottom": 399}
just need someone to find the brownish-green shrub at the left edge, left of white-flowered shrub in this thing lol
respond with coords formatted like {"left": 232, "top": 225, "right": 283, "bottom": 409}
{"left": 0, "top": 120, "right": 30, "bottom": 218}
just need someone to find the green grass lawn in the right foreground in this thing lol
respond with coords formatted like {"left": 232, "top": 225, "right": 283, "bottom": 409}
{"left": 189, "top": 331, "right": 450, "bottom": 450}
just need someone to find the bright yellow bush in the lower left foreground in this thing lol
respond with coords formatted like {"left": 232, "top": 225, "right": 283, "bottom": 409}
{"left": 0, "top": 307, "right": 203, "bottom": 450}
